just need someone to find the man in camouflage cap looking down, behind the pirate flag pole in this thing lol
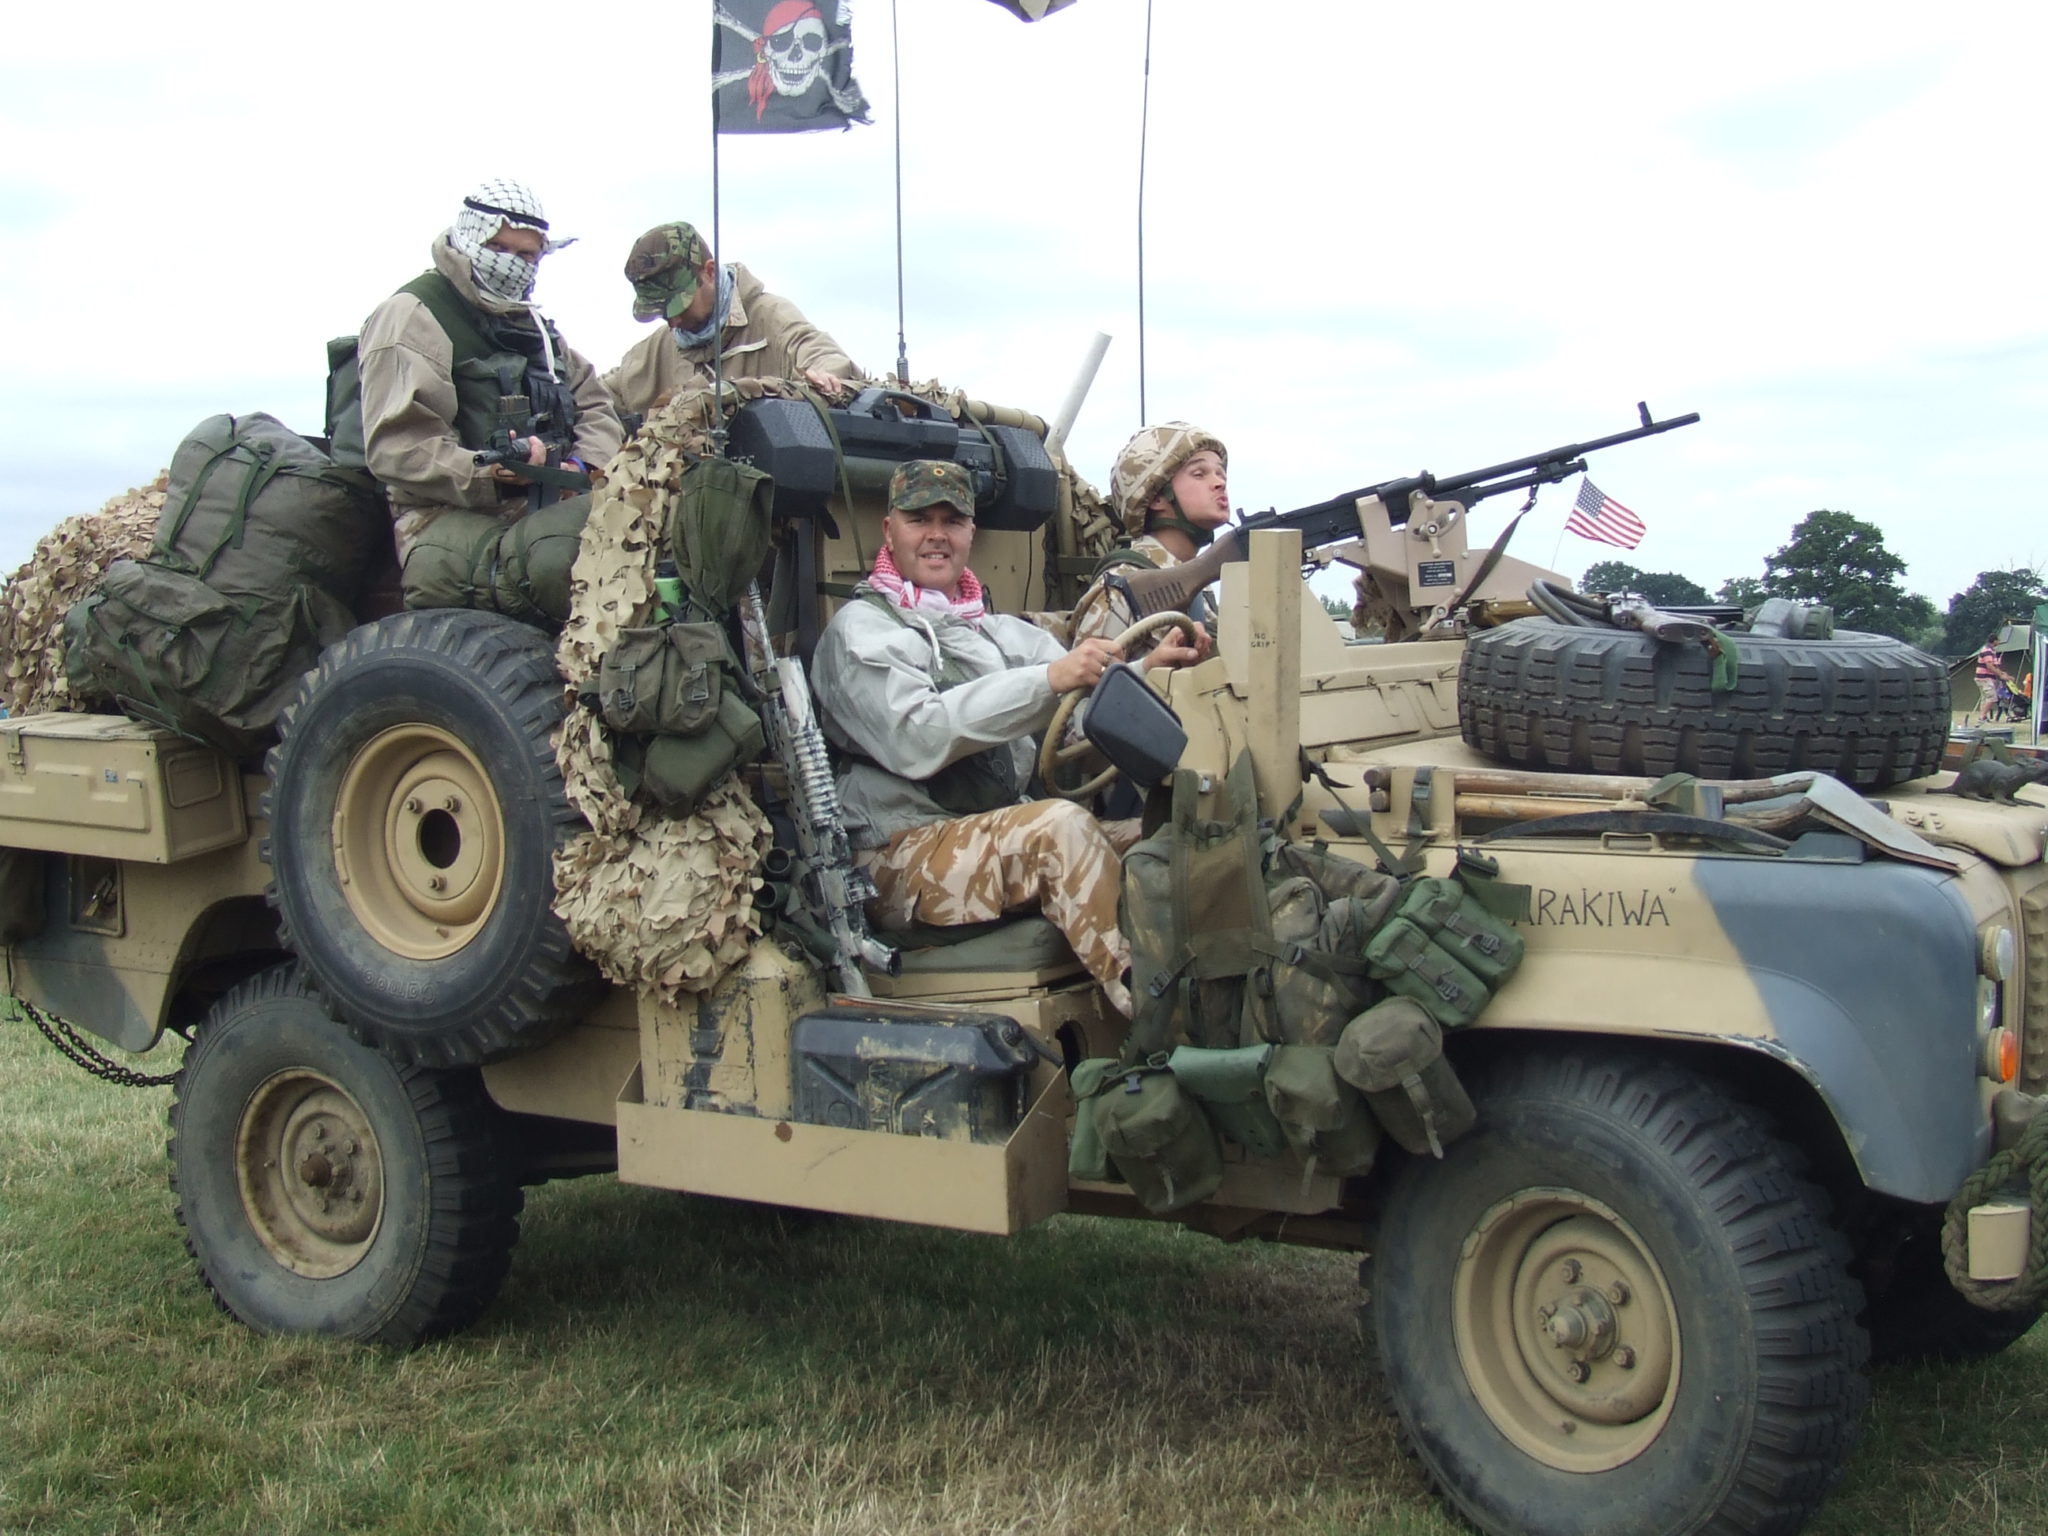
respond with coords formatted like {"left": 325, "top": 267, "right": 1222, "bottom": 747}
{"left": 604, "top": 221, "right": 860, "bottom": 412}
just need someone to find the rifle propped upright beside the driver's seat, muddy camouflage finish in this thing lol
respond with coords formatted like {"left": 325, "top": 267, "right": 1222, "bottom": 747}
{"left": 745, "top": 588, "right": 903, "bottom": 997}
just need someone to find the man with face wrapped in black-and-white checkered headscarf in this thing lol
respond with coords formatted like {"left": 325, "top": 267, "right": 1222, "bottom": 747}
{"left": 356, "top": 180, "right": 621, "bottom": 600}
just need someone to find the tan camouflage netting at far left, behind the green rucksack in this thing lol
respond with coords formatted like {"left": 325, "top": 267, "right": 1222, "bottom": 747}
{"left": 0, "top": 473, "right": 168, "bottom": 715}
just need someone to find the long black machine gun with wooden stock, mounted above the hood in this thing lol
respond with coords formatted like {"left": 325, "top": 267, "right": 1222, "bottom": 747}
{"left": 1104, "top": 401, "right": 1700, "bottom": 618}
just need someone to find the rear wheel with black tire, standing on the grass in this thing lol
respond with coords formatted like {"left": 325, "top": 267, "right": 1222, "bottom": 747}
{"left": 170, "top": 965, "right": 524, "bottom": 1348}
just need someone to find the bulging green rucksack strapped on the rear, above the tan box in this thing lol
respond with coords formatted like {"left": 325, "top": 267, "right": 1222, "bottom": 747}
{"left": 63, "top": 412, "right": 391, "bottom": 758}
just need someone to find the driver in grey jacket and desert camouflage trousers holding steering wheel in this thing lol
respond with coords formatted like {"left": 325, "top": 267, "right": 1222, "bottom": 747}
{"left": 813, "top": 459, "right": 1196, "bottom": 1018}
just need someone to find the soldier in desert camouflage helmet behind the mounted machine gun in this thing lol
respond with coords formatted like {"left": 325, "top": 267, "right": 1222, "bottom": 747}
{"left": 1071, "top": 422, "right": 1231, "bottom": 651}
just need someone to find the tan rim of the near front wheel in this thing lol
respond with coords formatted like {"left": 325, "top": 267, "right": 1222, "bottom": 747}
{"left": 1452, "top": 1190, "right": 1679, "bottom": 1473}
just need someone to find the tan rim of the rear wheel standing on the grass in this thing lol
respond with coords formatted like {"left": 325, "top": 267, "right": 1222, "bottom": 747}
{"left": 236, "top": 1071, "right": 383, "bottom": 1280}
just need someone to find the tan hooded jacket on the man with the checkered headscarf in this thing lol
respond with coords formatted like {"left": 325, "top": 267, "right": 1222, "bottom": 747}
{"left": 356, "top": 233, "right": 623, "bottom": 526}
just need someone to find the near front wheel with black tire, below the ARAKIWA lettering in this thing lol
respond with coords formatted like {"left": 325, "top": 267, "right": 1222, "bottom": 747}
{"left": 1370, "top": 1055, "right": 1868, "bottom": 1536}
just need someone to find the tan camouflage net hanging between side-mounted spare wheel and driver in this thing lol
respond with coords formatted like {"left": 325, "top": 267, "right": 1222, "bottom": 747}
{"left": 555, "top": 391, "right": 770, "bottom": 1004}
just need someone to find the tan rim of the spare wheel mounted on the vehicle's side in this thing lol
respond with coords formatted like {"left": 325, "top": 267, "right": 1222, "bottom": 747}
{"left": 334, "top": 725, "right": 504, "bottom": 961}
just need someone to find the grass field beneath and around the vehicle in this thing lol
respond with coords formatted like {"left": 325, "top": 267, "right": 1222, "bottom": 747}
{"left": 0, "top": 1016, "right": 2048, "bottom": 1536}
